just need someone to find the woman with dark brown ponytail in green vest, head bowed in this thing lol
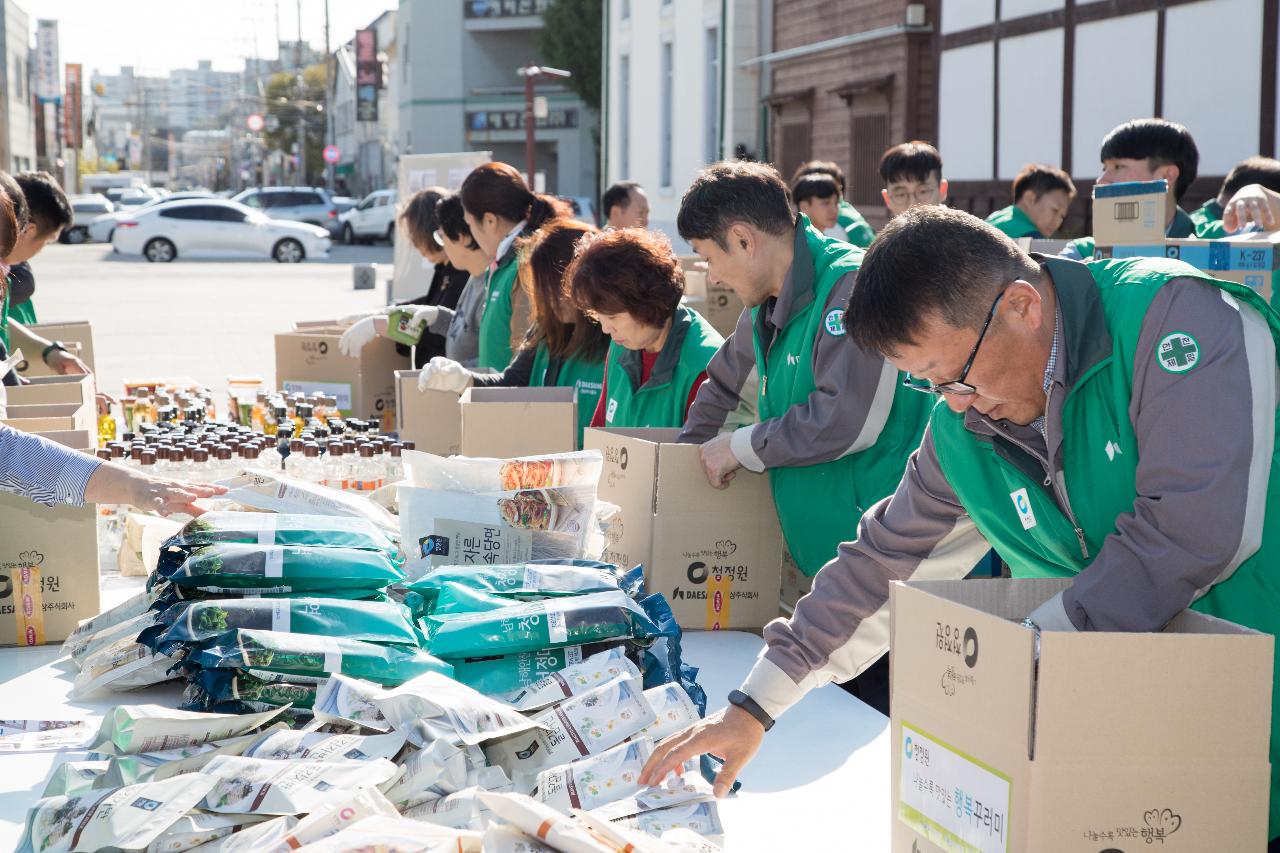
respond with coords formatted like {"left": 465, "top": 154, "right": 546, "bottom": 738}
{"left": 458, "top": 163, "right": 571, "bottom": 370}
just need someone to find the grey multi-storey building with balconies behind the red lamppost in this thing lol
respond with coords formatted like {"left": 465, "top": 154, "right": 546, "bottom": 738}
{"left": 390, "top": 0, "right": 596, "bottom": 199}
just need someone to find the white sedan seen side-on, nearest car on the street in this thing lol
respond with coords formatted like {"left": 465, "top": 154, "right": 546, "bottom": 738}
{"left": 111, "top": 199, "right": 330, "bottom": 264}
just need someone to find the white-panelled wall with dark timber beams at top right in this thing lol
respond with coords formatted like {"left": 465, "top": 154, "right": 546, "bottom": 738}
{"left": 938, "top": 0, "right": 1280, "bottom": 233}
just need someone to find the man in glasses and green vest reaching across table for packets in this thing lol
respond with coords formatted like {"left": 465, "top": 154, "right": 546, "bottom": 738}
{"left": 641, "top": 207, "right": 1280, "bottom": 838}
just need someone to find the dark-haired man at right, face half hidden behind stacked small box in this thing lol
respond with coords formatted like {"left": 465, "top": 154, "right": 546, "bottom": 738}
{"left": 1061, "top": 119, "right": 1199, "bottom": 260}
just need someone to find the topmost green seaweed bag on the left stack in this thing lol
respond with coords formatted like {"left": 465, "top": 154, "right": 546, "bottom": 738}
{"left": 164, "top": 512, "right": 396, "bottom": 556}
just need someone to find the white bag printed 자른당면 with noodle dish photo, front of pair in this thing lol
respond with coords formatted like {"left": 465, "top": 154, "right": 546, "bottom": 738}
{"left": 399, "top": 485, "right": 617, "bottom": 579}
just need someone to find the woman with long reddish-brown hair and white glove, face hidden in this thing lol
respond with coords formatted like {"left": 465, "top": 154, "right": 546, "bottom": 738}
{"left": 419, "top": 219, "right": 609, "bottom": 444}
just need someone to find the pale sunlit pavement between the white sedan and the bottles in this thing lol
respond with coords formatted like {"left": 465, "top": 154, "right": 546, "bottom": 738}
{"left": 27, "top": 243, "right": 392, "bottom": 403}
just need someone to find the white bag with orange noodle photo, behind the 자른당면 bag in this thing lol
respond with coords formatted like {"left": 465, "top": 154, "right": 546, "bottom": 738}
{"left": 401, "top": 451, "right": 604, "bottom": 492}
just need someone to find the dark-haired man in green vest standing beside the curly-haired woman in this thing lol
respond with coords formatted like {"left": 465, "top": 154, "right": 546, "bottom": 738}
{"left": 677, "top": 163, "right": 931, "bottom": 706}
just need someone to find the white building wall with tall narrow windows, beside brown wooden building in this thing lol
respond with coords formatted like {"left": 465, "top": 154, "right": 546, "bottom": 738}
{"left": 602, "top": 0, "right": 769, "bottom": 244}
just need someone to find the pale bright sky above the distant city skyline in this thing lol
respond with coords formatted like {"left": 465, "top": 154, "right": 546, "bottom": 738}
{"left": 17, "top": 0, "right": 398, "bottom": 79}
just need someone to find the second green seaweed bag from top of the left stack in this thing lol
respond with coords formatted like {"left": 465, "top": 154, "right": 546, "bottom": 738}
{"left": 152, "top": 543, "right": 404, "bottom": 594}
